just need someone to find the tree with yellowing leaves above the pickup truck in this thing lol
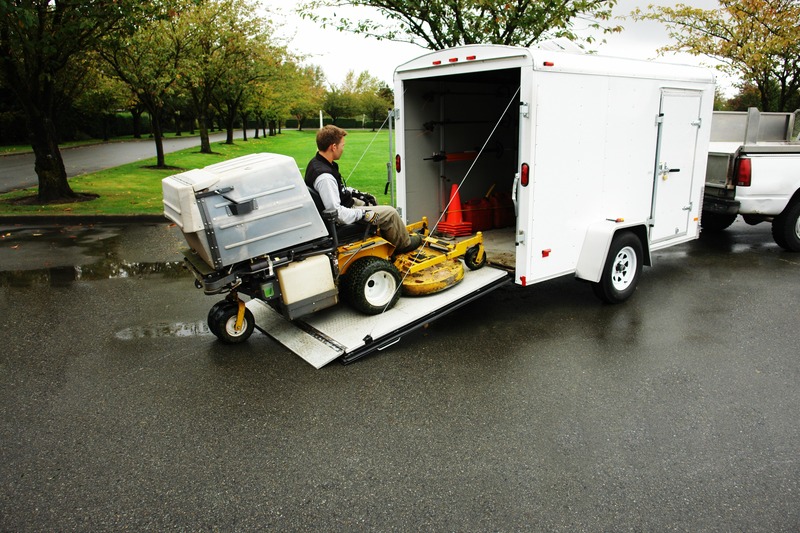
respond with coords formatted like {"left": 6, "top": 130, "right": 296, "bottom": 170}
{"left": 631, "top": 0, "right": 800, "bottom": 111}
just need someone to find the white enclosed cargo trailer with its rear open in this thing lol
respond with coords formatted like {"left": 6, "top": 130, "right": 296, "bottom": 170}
{"left": 395, "top": 45, "right": 714, "bottom": 302}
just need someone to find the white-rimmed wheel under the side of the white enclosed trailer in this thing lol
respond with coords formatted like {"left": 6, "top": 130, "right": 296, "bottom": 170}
{"left": 592, "top": 231, "right": 642, "bottom": 304}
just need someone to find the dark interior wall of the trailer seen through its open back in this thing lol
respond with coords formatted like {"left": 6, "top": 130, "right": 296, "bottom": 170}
{"left": 401, "top": 68, "right": 520, "bottom": 222}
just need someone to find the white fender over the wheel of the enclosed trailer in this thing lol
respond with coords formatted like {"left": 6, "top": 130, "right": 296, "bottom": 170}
{"left": 575, "top": 220, "right": 651, "bottom": 283}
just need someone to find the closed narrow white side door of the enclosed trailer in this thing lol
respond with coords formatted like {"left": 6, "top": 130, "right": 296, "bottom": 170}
{"left": 650, "top": 89, "right": 702, "bottom": 243}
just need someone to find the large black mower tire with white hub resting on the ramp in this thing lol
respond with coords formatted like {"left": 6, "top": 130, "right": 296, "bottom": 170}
{"left": 342, "top": 256, "right": 400, "bottom": 315}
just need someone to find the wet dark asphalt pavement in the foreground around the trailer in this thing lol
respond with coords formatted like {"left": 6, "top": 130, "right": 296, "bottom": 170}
{"left": 0, "top": 218, "right": 800, "bottom": 532}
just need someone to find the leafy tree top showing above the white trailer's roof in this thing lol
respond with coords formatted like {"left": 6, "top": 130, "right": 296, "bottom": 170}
{"left": 299, "top": 0, "right": 621, "bottom": 50}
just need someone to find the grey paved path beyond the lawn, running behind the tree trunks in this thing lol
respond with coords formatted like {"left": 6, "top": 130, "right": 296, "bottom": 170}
{"left": 0, "top": 130, "right": 242, "bottom": 193}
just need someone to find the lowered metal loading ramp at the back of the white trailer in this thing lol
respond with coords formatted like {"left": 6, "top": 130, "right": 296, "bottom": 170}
{"left": 247, "top": 266, "right": 510, "bottom": 368}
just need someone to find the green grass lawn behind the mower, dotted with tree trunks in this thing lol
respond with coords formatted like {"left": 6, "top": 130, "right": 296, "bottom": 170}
{"left": 0, "top": 130, "right": 390, "bottom": 216}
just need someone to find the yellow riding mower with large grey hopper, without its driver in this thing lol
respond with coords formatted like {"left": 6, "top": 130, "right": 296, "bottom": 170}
{"left": 162, "top": 153, "right": 486, "bottom": 343}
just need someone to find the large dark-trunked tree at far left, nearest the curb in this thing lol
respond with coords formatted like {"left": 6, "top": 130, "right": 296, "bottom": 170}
{"left": 0, "top": 0, "right": 158, "bottom": 203}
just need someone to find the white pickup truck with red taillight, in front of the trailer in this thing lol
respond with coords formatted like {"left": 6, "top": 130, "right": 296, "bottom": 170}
{"left": 701, "top": 108, "right": 800, "bottom": 252}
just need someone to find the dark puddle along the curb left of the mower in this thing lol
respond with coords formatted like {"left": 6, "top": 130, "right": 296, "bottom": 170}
{"left": 0, "top": 226, "right": 189, "bottom": 287}
